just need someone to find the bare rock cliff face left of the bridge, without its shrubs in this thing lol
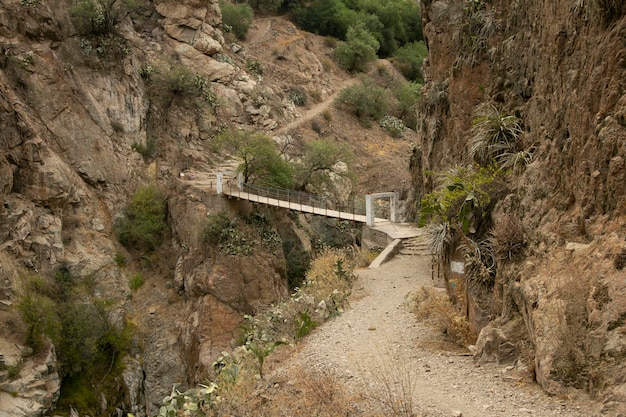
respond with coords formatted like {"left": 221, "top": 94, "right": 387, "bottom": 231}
{"left": 0, "top": 0, "right": 298, "bottom": 416}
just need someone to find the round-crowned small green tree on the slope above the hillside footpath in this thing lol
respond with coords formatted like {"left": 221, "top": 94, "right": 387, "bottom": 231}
{"left": 334, "top": 21, "right": 380, "bottom": 72}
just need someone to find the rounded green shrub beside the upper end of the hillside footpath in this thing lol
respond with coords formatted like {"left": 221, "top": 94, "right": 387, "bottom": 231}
{"left": 335, "top": 77, "right": 389, "bottom": 127}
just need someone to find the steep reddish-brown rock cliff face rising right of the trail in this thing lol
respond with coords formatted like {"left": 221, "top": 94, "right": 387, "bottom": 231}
{"left": 413, "top": 0, "right": 626, "bottom": 410}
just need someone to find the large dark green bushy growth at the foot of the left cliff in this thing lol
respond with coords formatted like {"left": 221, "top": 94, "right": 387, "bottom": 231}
{"left": 17, "top": 266, "right": 132, "bottom": 415}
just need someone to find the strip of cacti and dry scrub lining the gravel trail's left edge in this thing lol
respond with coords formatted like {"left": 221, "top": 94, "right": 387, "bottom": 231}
{"left": 151, "top": 250, "right": 354, "bottom": 417}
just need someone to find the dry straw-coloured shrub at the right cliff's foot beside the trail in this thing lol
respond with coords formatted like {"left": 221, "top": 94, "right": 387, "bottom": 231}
{"left": 413, "top": 287, "right": 476, "bottom": 346}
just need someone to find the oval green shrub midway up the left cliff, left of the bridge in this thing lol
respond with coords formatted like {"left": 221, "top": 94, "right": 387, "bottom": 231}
{"left": 115, "top": 185, "right": 167, "bottom": 252}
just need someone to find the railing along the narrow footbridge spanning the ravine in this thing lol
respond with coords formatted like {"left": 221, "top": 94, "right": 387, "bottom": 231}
{"left": 225, "top": 182, "right": 365, "bottom": 216}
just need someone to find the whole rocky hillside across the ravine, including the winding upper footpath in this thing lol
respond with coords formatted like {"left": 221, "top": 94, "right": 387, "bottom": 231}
{"left": 0, "top": 0, "right": 415, "bottom": 416}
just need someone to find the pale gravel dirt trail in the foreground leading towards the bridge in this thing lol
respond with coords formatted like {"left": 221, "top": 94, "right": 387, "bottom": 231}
{"left": 276, "top": 255, "right": 599, "bottom": 417}
